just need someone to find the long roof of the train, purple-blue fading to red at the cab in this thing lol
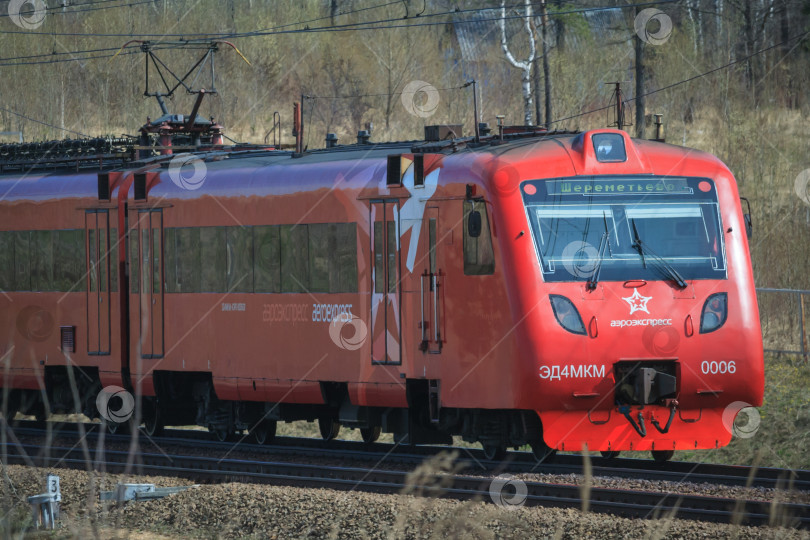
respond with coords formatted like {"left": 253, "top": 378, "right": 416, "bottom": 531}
{"left": 0, "top": 128, "right": 724, "bottom": 201}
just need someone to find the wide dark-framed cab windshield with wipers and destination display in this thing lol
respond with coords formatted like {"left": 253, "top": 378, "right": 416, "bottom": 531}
{"left": 521, "top": 176, "right": 727, "bottom": 286}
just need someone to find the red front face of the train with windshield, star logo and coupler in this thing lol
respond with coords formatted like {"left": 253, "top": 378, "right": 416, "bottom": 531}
{"left": 520, "top": 166, "right": 763, "bottom": 459}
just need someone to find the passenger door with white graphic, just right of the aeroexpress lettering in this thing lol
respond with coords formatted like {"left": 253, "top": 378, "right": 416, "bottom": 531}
{"left": 369, "top": 200, "right": 402, "bottom": 364}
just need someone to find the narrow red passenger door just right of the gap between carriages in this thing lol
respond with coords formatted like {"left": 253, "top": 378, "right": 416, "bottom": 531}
{"left": 133, "top": 208, "right": 164, "bottom": 358}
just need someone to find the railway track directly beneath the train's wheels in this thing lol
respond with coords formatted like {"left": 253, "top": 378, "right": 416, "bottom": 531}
{"left": 3, "top": 422, "right": 810, "bottom": 491}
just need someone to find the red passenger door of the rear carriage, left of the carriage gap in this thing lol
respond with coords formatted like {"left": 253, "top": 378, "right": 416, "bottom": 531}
{"left": 84, "top": 209, "right": 110, "bottom": 355}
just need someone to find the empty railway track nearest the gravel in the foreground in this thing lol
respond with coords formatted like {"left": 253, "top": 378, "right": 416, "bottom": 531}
{"left": 3, "top": 443, "right": 810, "bottom": 529}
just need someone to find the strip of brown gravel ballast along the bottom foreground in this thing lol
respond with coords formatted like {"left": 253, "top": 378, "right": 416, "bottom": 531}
{"left": 2, "top": 465, "right": 810, "bottom": 538}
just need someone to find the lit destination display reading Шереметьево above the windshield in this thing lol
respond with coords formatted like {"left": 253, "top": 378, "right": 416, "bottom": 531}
{"left": 546, "top": 178, "right": 692, "bottom": 195}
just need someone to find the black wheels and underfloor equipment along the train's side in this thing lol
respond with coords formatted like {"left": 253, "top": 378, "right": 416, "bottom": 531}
{"left": 2, "top": 366, "right": 555, "bottom": 460}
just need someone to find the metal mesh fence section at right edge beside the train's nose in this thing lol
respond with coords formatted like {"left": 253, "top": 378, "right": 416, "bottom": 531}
{"left": 757, "top": 288, "right": 810, "bottom": 361}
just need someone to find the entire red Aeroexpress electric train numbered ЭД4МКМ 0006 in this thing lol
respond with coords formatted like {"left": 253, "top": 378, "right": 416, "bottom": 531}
{"left": 0, "top": 122, "right": 764, "bottom": 459}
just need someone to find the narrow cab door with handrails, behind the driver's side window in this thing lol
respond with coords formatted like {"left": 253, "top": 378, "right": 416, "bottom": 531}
{"left": 417, "top": 207, "right": 444, "bottom": 354}
